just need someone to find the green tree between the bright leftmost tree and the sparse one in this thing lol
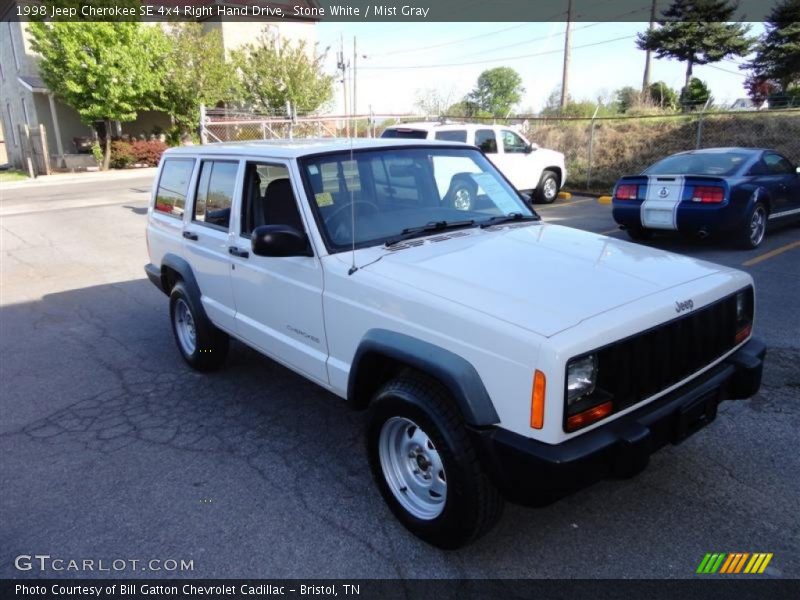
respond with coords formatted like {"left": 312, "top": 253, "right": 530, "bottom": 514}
{"left": 159, "top": 23, "right": 238, "bottom": 133}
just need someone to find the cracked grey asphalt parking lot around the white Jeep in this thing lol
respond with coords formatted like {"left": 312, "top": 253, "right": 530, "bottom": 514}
{"left": 0, "top": 174, "right": 800, "bottom": 578}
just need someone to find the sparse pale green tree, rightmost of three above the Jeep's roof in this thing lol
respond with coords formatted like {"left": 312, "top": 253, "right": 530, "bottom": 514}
{"left": 234, "top": 34, "right": 333, "bottom": 112}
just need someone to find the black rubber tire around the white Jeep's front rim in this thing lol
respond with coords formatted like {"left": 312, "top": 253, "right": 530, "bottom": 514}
{"left": 366, "top": 371, "right": 503, "bottom": 549}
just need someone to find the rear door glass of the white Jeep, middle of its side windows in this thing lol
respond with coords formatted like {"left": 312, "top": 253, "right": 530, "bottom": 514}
{"left": 192, "top": 160, "right": 239, "bottom": 230}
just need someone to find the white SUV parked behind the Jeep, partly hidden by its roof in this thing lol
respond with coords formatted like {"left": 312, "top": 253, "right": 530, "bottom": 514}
{"left": 381, "top": 122, "right": 567, "bottom": 204}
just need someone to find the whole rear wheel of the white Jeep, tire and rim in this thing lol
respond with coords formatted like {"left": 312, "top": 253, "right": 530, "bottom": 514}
{"left": 169, "top": 281, "right": 228, "bottom": 371}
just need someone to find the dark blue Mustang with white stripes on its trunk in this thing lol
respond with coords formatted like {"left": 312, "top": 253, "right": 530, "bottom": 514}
{"left": 612, "top": 148, "right": 800, "bottom": 249}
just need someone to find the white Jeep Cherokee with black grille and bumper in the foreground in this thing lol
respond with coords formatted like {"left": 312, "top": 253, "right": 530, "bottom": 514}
{"left": 146, "top": 139, "right": 765, "bottom": 548}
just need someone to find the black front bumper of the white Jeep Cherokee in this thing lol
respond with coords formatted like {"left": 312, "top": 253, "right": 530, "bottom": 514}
{"left": 471, "top": 339, "right": 766, "bottom": 505}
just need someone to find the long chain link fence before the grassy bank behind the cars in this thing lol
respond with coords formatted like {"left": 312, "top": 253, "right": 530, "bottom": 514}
{"left": 200, "top": 108, "right": 800, "bottom": 193}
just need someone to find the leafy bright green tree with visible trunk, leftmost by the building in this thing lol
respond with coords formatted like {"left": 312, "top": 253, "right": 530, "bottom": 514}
{"left": 30, "top": 21, "right": 164, "bottom": 170}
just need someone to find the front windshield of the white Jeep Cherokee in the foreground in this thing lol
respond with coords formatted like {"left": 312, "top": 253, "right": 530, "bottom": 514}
{"left": 300, "top": 147, "right": 534, "bottom": 252}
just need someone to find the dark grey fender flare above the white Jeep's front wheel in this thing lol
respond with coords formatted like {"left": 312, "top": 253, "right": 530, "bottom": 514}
{"left": 347, "top": 329, "right": 500, "bottom": 427}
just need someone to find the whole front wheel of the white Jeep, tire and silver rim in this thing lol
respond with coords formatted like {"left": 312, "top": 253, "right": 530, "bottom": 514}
{"left": 367, "top": 373, "right": 503, "bottom": 549}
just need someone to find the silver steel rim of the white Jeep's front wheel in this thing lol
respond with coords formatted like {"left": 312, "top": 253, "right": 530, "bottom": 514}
{"left": 378, "top": 417, "right": 447, "bottom": 521}
